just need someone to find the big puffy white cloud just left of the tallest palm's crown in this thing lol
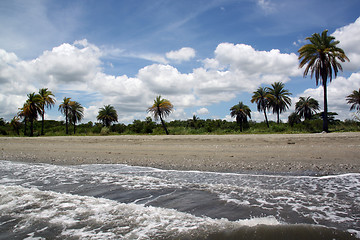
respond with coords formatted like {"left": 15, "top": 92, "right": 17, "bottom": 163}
{"left": 193, "top": 43, "right": 301, "bottom": 105}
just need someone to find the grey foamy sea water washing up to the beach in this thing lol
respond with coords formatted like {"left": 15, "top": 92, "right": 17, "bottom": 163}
{"left": 0, "top": 161, "right": 360, "bottom": 239}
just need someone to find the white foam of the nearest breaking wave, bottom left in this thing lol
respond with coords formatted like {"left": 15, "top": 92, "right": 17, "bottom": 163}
{"left": 0, "top": 185, "right": 280, "bottom": 239}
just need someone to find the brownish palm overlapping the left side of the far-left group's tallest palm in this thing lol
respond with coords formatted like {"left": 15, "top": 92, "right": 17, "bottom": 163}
{"left": 23, "top": 92, "right": 41, "bottom": 137}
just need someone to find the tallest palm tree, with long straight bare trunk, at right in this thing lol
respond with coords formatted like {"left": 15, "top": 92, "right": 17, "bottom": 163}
{"left": 298, "top": 30, "right": 350, "bottom": 132}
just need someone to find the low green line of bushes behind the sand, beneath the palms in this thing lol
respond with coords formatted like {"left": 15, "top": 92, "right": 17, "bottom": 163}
{"left": 0, "top": 113, "right": 360, "bottom": 136}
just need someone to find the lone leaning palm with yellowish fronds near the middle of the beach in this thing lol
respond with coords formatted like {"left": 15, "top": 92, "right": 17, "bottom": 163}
{"left": 147, "top": 95, "right": 174, "bottom": 135}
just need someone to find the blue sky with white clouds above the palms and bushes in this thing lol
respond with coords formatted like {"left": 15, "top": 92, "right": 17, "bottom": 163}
{"left": 0, "top": 0, "right": 360, "bottom": 124}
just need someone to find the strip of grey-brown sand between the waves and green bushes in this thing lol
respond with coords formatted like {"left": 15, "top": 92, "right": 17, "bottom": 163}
{"left": 0, "top": 132, "right": 360, "bottom": 175}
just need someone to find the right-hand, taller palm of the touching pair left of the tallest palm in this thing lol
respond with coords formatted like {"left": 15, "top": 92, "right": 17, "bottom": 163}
{"left": 266, "top": 82, "right": 291, "bottom": 124}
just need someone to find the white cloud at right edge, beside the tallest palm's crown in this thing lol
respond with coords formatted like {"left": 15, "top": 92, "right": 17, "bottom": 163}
{"left": 332, "top": 17, "right": 360, "bottom": 71}
